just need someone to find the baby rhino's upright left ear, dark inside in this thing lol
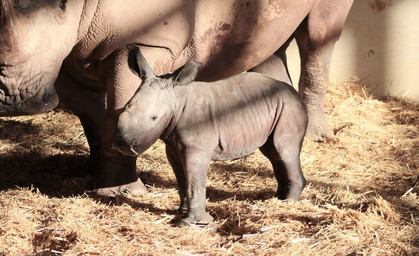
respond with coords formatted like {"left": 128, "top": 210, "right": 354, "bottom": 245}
{"left": 127, "top": 44, "right": 156, "bottom": 80}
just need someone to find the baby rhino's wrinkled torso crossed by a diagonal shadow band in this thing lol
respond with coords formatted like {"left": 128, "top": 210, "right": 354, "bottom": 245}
{"left": 172, "top": 72, "right": 306, "bottom": 160}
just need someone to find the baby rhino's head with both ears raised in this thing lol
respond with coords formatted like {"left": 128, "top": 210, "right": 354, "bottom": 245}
{"left": 113, "top": 45, "right": 201, "bottom": 155}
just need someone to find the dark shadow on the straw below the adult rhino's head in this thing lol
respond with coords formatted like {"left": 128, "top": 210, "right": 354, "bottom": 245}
{"left": 0, "top": 153, "right": 92, "bottom": 197}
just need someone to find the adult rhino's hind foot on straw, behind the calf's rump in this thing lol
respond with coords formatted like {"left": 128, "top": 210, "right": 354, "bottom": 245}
{"left": 307, "top": 109, "right": 334, "bottom": 142}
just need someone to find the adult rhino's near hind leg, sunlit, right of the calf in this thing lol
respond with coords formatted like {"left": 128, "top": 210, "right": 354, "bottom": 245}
{"left": 295, "top": 0, "right": 353, "bottom": 141}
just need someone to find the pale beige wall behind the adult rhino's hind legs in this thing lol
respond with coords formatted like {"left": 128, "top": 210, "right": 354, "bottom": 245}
{"left": 287, "top": 0, "right": 419, "bottom": 100}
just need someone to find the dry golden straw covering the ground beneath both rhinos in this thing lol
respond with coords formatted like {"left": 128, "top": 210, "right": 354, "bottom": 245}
{"left": 0, "top": 82, "right": 419, "bottom": 255}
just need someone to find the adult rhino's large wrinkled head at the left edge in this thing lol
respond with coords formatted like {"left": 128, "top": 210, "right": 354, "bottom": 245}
{"left": 0, "top": 0, "right": 87, "bottom": 116}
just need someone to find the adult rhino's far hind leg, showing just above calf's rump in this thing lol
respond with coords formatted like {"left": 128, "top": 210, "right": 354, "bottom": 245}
{"left": 249, "top": 37, "right": 293, "bottom": 84}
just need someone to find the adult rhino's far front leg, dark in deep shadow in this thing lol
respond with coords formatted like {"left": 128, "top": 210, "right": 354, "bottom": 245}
{"left": 56, "top": 67, "right": 105, "bottom": 176}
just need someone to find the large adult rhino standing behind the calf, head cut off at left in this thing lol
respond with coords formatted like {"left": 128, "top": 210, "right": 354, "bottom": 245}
{"left": 0, "top": 0, "right": 353, "bottom": 195}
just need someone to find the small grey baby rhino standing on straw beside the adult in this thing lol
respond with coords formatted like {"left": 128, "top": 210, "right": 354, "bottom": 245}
{"left": 113, "top": 46, "right": 307, "bottom": 226}
